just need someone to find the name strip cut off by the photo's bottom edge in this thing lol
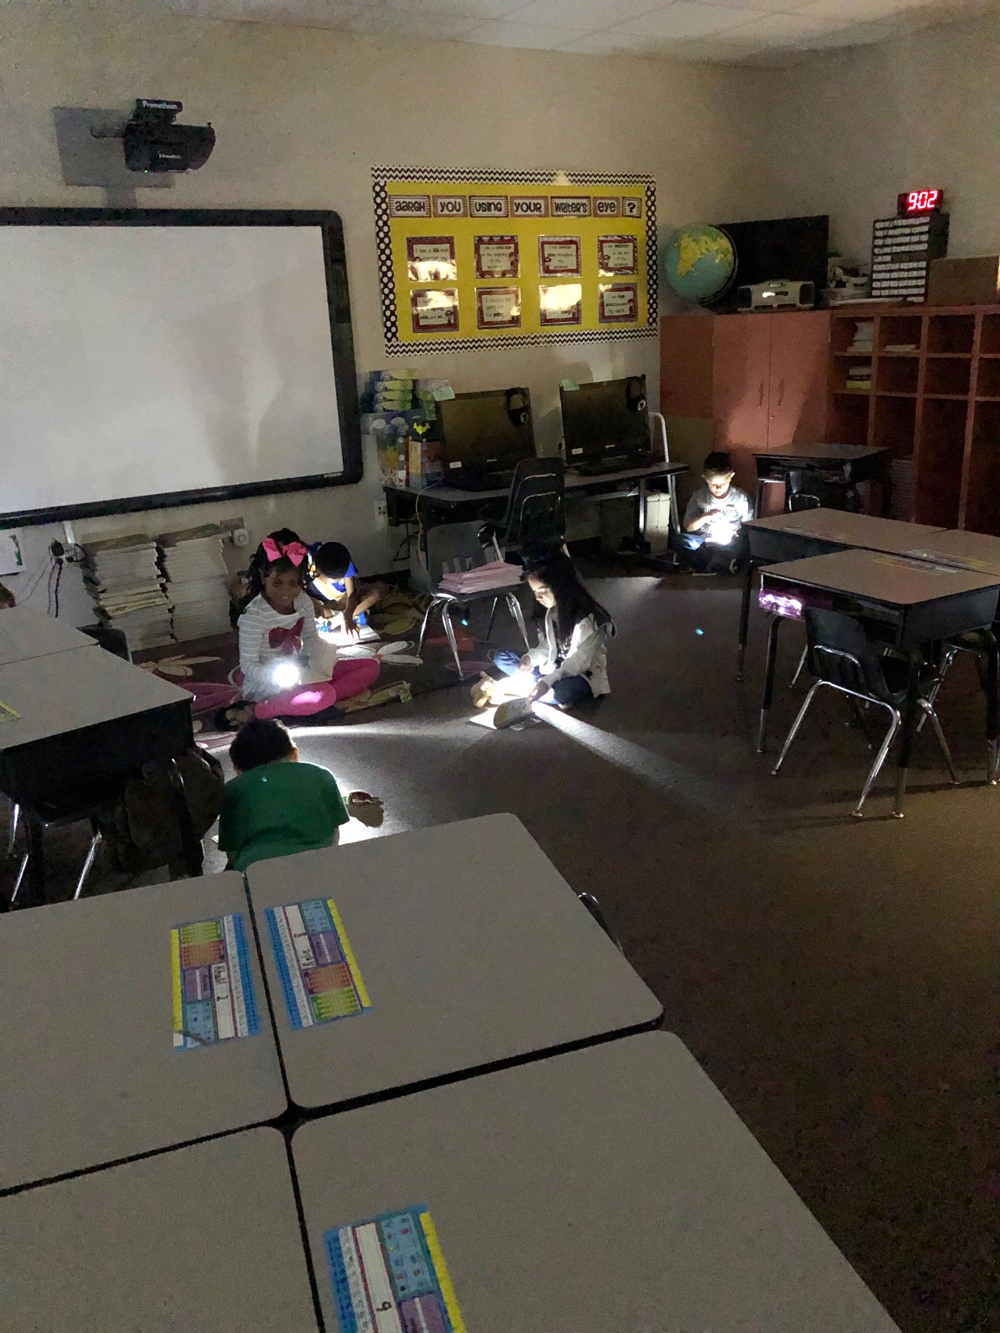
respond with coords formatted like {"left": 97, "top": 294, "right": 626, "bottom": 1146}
{"left": 329, "top": 1204, "right": 467, "bottom": 1333}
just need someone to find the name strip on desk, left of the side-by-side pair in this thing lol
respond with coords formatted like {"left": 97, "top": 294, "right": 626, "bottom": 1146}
{"left": 171, "top": 912, "right": 260, "bottom": 1050}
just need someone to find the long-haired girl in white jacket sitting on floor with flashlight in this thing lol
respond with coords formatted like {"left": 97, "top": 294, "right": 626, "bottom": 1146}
{"left": 493, "top": 552, "right": 615, "bottom": 708}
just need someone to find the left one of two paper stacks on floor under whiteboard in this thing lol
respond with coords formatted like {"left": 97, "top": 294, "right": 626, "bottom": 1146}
{"left": 83, "top": 532, "right": 173, "bottom": 652}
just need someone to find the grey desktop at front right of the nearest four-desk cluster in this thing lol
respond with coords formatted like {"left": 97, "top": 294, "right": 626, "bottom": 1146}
{"left": 292, "top": 1033, "right": 899, "bottom": 1333}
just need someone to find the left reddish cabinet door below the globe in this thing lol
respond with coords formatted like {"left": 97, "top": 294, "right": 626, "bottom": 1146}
{"left": 712, "top": 315, "right": 772, "bottom": 451}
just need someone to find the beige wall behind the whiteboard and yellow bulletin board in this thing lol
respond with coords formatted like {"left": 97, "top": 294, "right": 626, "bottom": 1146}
{"left": 0, "top": 3, "right": 767, "bottom": 623}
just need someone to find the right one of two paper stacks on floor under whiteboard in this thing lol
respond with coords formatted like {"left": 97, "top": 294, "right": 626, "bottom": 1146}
{"left": 157, "top": 524, "right": 232, "bottom": 644}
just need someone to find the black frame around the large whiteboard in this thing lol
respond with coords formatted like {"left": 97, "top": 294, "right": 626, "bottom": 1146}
{"left": 0, "top": 208, "right": 364, "bottom": 527}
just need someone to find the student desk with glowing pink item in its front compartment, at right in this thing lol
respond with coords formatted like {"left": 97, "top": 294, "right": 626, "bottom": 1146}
{"left": 757, "top": 549, "right": 1000, "bottom": 796}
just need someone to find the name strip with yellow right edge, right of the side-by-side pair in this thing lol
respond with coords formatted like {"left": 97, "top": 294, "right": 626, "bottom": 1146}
{"left": 264, "top": 898, "right": 372, "bottom": 1028}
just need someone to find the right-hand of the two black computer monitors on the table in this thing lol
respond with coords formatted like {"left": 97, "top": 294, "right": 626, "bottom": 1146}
{"left": 559, "top": 375, "right": 649, "bottom": 468}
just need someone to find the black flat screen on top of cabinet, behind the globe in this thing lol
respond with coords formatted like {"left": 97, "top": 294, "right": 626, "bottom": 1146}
{"left": 708, "top": 213, "right": 829, "bottom": 315}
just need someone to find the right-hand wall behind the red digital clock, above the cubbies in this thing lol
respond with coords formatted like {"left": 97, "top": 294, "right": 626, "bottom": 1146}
{"left": 743, "top": 15, "right": 1000, "bottom": 263}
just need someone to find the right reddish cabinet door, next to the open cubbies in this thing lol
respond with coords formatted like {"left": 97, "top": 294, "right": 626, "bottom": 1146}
{"left": 761, "top": 311, "right": 829, "bottom": 449}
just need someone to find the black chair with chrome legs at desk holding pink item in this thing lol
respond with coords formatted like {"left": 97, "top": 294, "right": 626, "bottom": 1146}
{"left": 772, "top": 607, "right": 957, "bottom": 818}
